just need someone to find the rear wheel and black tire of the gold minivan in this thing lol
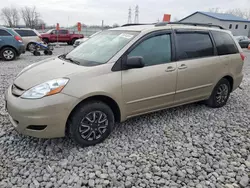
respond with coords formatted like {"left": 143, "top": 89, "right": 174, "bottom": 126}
{"left": 206, "top": 78, "right": 231, "bottom": 108}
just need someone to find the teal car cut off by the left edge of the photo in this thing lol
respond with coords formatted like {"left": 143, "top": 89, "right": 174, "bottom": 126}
{"left": 0, "top": 27, "right": 25, "bottom": 61}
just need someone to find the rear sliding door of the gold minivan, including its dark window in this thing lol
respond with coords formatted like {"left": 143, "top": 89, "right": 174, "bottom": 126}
{"left": 175, "top": 31, "right": 221, "bottom": 104}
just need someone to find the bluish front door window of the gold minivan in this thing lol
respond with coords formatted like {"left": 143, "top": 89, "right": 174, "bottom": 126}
{"left": 128, "top": 34, "right": 171, "bottom": 66}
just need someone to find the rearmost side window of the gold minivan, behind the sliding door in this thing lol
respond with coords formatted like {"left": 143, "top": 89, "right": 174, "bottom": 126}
{"left": 212, "top": 31, "right": 239, "bottom": 55}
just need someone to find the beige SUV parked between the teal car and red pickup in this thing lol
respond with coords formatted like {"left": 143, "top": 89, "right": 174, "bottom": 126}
{"left": 14, "top": 28, "right": 42, "bottom": 51}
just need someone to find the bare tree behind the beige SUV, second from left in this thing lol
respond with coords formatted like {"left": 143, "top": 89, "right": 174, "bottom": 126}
{"left": 21, "top": 6, "right": 40, "bottom": 29}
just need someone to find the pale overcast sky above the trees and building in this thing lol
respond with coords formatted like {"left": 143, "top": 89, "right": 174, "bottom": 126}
{"left": 0, "top": 0, "right": 250, "bottom": 26}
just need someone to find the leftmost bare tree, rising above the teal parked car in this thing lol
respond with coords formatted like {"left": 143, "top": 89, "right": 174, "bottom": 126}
{"left": 1, "top": 7, "right": 20, "bottom": 27}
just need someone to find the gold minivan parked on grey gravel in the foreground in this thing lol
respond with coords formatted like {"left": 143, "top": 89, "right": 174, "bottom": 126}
{"left": 6, "top": 23, "right": 244, "bottom": 146}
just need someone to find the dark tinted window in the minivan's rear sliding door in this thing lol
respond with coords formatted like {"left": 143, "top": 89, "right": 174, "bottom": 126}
{"left": 176, "top": 32, "right": 214, "bottom": 60}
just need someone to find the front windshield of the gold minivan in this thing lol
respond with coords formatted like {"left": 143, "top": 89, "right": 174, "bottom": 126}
{"left": 66, "top": 30, "right": 138, "bottom": 66}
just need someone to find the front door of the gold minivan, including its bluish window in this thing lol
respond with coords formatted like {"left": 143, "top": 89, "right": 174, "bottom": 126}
{"left": 122, "top": 31, "right": 177, "bottom": 117}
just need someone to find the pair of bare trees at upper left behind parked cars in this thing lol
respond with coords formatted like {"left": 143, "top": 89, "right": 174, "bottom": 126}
{"left": 0, "top": 6, "right": 45, "bottom": 29}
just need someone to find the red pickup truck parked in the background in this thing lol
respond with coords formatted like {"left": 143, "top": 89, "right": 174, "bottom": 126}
{"left": 41, "top": 29, "right": 84, "bottom": 45}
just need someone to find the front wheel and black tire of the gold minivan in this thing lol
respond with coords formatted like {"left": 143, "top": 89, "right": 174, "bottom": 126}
{"left": 67, "top": 101, "right": 115, "bottom": 147}
